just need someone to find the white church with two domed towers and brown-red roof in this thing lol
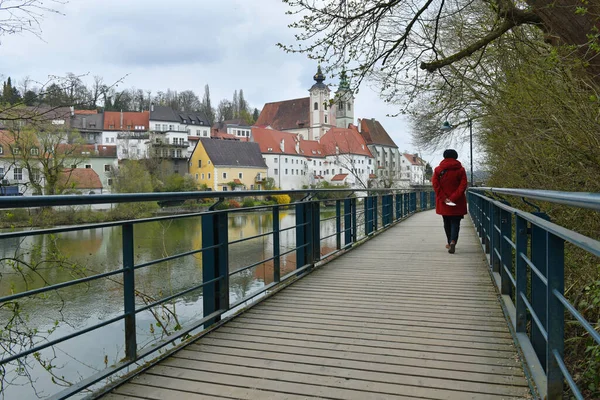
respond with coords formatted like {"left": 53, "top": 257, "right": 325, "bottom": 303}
{"left": 254, "top": 66, "right": 354, "bottom": 140}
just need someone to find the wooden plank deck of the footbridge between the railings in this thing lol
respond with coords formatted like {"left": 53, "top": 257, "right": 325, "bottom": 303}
{"left": 104, "top": 211, "right": 531, "bottom": 400}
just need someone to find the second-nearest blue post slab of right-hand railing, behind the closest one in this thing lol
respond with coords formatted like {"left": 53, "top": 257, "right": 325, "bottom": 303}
{"left": 530, "top": 217, "right": 548, "bottom": 372}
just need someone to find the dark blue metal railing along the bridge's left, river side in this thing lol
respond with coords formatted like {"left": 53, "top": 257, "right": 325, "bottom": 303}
{"left": 0, "top": 189, "right": 435, "bottom": 399}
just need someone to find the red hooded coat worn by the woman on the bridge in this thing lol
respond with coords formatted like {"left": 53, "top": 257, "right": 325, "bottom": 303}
{"left": 431, "top": 158, "right": 468, "bottom": 215}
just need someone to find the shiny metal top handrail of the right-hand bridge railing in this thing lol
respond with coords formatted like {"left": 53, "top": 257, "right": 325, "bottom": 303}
{"left": 469, "top": 187, "right": 600, "bottom": 210}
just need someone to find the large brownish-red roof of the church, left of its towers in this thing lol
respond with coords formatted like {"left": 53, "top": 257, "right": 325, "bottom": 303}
{"left": 255, "top": 97, "right": 310, "bottom": 130}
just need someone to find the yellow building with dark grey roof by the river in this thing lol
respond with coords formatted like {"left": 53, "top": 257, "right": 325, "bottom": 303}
{"left": 190, "top": 138, "right": 267, "bottom": 191}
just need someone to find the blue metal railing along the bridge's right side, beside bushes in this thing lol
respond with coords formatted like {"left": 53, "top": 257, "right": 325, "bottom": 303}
{"left": 468, "top": 188, "right": 600, "bottom": 399}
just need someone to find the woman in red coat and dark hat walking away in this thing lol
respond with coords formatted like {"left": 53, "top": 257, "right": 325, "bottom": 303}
{"left": 431, "top": 149, "right": 467, "bottom": 254}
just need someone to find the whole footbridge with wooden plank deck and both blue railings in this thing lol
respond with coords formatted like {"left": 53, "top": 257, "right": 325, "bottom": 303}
{"left": 0, "top": 188, "right": 600, "bottom": 400}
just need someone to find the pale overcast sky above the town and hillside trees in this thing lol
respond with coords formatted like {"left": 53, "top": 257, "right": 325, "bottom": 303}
{"left": 0, "top": 0, "right": 468, "bottom": 165}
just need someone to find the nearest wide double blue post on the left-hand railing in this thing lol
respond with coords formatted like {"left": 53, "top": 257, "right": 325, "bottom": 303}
{"left": 202, "top": 211, "right": 229, "bottom": 328}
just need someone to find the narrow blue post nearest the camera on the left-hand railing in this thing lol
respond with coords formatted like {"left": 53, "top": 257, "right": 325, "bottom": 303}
{"left": 122, "top": 224, "right": 137, "bottom": 360}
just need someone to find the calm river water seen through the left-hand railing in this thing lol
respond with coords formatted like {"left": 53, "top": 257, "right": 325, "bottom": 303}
{"left": 0, "top": 209, "right": 346, "bottom": 399}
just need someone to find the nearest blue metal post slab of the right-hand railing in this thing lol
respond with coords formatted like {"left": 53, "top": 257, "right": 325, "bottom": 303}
{"left": 546, "top": 232, "right": 565, "bottom": 399}
